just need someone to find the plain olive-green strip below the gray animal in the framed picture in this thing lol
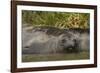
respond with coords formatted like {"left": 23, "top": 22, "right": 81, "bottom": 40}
{"left": 22, "top": 51, "right": 89, "bottom": 62}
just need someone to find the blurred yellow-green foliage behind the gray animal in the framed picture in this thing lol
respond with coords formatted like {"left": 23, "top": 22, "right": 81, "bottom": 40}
{"left": 22, "top": 10, "right": 90, "bottom": 29}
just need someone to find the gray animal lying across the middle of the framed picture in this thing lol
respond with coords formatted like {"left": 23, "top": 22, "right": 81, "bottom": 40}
{"left": 22, "top": 27, "right": 89, "bottom": 54}
